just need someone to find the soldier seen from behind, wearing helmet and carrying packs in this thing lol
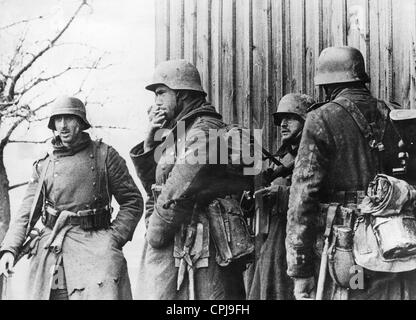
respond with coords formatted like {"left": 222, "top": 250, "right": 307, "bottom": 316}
{"left": 286, "top": 47, "right": 416, "bottom": 299}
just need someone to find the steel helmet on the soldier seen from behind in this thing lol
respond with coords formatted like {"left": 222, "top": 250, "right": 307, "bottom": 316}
{"left": 315, "top": 47, "right": 370, "bottom": 86}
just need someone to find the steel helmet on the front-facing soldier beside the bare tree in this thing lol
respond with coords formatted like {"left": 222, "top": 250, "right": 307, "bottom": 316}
{"left": 48, "top": 96, "right": 91, "bottom": 130}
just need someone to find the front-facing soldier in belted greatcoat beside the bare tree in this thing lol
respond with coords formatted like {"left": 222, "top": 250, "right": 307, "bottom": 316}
{"left": 0, "top": 96, "right": 143, "bottom": 300}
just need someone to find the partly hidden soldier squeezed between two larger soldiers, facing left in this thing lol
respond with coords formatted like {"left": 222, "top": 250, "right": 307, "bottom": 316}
{"left": 248, "top": 93, "right": 314, "bottom": 300}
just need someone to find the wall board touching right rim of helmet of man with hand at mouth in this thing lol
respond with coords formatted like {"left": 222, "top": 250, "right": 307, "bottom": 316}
{"left": 196, "top": 0, "right": 211, "bottom": 100}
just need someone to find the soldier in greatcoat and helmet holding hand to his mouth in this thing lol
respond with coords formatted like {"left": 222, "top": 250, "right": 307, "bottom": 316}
{"left": 131, "top": 60, "right": 249, "bottom": 300}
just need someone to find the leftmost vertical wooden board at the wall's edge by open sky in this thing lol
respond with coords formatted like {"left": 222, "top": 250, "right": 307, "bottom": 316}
{"left": 155, "top": 0, "right": 170, "bottom": 65}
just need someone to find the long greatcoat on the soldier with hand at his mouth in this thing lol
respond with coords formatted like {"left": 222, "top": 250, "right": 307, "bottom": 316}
{"left": 131, "top": 99, "right": 245, "bottom": 300}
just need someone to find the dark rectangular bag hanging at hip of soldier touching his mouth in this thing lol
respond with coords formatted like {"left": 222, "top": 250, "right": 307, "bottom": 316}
{"left": 207, "top": 198, "right": 255, "bottom": 267}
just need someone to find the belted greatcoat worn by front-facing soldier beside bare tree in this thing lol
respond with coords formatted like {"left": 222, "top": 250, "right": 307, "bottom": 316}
{"left": 1, "top": 133, "right": 143, "bottom": 300}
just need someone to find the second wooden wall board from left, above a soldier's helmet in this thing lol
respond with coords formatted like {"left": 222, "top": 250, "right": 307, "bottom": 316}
{"left": 170, "top": 0, "right": 184, "bottom": 59}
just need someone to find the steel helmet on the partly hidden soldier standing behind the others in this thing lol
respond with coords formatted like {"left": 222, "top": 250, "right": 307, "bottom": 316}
{"left": 273, "top": 93, "right": 315, "bottom": 126}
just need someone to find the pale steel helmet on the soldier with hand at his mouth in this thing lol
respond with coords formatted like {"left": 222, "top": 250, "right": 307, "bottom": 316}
{"left": 146, "top": 60, "right": 206, "bottom": 95}
